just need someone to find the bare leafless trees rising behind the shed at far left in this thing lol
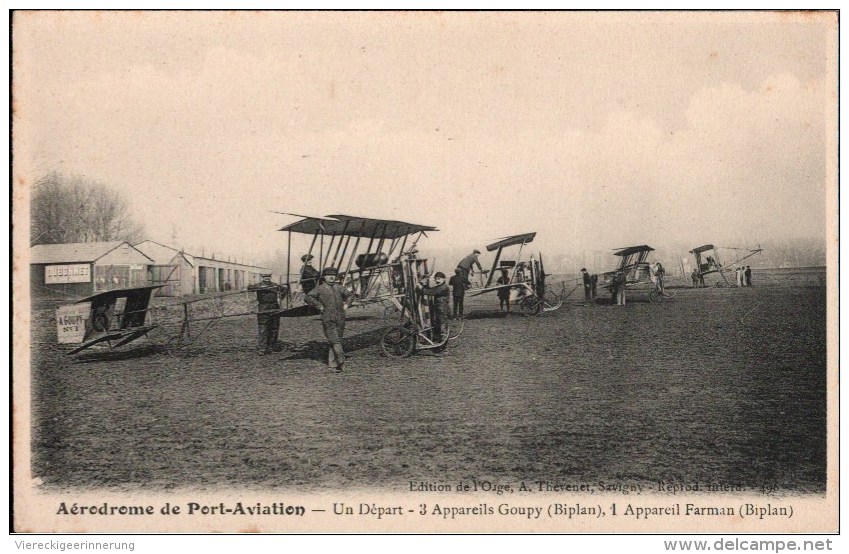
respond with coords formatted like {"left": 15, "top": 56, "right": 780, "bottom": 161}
{"left": 30, "top": 172, "right": 145, "bottom": 245}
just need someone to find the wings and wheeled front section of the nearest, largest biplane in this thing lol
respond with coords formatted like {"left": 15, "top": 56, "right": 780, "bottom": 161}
{"left": 276, "top": 212, "right": 462, "bottom": 357}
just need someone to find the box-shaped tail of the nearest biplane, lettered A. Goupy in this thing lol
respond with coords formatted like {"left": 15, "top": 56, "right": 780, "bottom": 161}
{"left": 56, "top": 285, "right": 162, "bottom": 354}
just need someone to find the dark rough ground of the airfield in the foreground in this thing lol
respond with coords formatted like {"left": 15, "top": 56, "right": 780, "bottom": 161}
{"left": 31, "top": 268, "right": 826, "bottom": 493}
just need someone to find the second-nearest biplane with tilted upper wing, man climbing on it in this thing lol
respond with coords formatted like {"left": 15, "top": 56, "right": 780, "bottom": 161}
{"left": 469, "top": 233, "right": 563, "bottom": 316}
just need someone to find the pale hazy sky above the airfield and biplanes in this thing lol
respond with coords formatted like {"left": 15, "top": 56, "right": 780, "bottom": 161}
{"left": 13, "top": 12, "right": 837, "bottom": 270}
